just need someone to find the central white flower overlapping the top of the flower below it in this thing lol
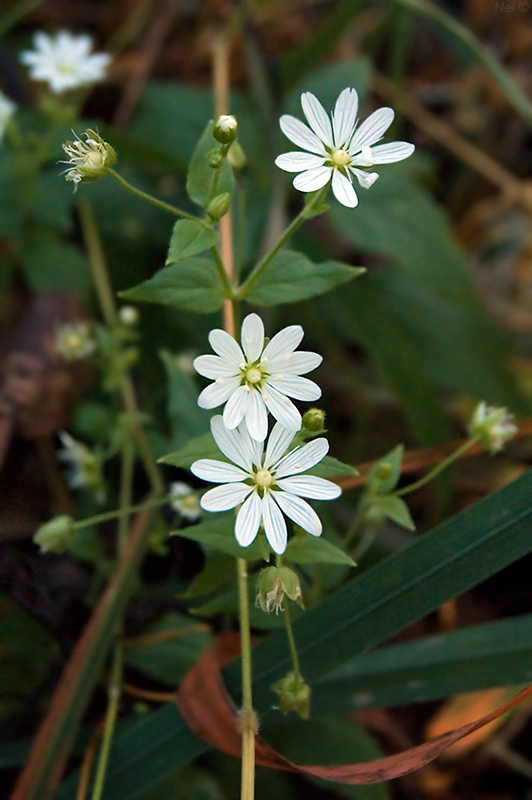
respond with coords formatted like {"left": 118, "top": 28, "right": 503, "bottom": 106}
{"left": 194, "top": 314, "right": 322, "bottom": 442}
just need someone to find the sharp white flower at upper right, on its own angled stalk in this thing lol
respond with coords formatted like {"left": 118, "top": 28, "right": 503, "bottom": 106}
{"left": 275, "top": 89, "right": 415, "bottom": 208}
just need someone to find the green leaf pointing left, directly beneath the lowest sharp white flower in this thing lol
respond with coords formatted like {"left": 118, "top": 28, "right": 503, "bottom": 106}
{"left": 170, "top": 512, "right": 270, "bottom": 561}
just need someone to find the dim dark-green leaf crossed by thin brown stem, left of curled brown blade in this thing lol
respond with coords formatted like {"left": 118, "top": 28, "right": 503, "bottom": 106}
{"left": 124, "top": 611, "right": 212, "bottom": 686}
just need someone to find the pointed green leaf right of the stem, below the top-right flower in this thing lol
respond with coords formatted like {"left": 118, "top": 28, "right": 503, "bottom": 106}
{"left": 243, "top": 250, "right": 366, "bottom": 306}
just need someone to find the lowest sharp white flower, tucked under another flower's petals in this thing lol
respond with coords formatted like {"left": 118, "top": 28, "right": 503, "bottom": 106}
{"left": 190, "top": 416, "right": 341, "bottom": 553}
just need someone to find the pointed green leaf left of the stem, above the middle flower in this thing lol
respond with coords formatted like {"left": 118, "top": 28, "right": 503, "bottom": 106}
{"left": 119, "top": 257, "right": 225, "bottom": 314}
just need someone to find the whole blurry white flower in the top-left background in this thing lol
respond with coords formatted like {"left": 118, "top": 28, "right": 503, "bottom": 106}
{"left": 20, "top": 31, "right": 111, "bottom": 92}
